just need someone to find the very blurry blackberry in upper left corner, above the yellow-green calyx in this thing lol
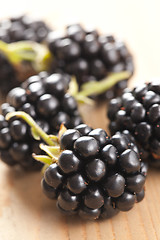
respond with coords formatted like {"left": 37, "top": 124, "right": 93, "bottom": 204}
{"left": 0, "top": 15, "right": 50, "bottom": 43}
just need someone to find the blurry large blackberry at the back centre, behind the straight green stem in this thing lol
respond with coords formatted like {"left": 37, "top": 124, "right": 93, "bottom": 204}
{"left": 47, "top": 24, "right": 134, "bottom": 99}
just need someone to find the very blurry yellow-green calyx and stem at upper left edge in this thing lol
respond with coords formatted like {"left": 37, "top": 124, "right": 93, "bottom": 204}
{"left": 0, "top": 40, "right": 52, "bottom": 72}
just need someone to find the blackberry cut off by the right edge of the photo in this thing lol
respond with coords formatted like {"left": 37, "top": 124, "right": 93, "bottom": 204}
{"left": 108, "top": 80, "right": 160, "bottom": 167}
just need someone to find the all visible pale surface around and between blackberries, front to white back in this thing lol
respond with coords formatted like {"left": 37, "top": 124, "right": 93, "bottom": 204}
{"left": 0, "top": 0, "right": 160, "bottom": 240}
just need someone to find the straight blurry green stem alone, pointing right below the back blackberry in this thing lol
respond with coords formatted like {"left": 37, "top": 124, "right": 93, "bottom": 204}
{"left": 75, "top": 71, "right": 131, "bottom": 100}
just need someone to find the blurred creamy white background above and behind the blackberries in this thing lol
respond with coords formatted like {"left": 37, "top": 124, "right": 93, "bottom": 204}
{"left": 0, "top": 0, "right": 160, "bottom": 86}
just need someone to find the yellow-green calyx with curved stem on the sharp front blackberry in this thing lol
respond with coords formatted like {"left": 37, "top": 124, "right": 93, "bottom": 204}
{"left": 6, "top": 111, "right": 66, "bottom": 167}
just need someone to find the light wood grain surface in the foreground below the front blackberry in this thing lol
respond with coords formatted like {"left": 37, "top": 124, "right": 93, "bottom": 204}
{"left": 0, "top": 163, "right": 160, "bottom": 240}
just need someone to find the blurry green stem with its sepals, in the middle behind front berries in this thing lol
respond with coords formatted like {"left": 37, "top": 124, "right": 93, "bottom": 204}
{"left": 69, "top": 71, "right": 131, "bottom": 105}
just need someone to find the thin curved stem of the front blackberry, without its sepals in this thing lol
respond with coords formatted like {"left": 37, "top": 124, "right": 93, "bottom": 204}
{"left": 6, "top": 111, "right": 55, "bottom": 146}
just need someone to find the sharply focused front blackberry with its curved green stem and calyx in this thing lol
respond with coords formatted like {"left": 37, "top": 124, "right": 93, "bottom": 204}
{"left": 7, "top": 112, "right": 147, "bottom": 220}
